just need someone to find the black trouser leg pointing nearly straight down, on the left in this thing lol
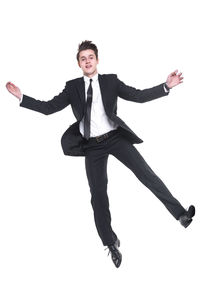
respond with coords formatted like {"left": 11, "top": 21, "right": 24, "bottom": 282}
{"left": 85, "top": 150, "right": 117, "bottom": 245}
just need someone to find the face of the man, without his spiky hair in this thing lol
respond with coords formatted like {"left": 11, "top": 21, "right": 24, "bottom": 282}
{"left": 78, "top": 49, "right": 99, "bottom": 78}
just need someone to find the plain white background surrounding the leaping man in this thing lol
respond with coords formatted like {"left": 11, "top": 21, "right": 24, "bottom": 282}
{"left": 0, "top": 0, "right": 200, "bottom": 300}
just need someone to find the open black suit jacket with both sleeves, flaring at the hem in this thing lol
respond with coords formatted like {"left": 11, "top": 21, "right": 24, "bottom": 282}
{"left": 20, "top": 74, "right": 169, "bottom": 156}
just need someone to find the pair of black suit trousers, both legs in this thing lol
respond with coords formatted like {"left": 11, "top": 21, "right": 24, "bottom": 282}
{"left": 84, "top": 130, "right": 185, "bottom": 245}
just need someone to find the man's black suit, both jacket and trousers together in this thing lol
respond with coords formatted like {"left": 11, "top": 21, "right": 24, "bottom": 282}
{"left": 20, "top": 74, "right": 185, "bottom": 245}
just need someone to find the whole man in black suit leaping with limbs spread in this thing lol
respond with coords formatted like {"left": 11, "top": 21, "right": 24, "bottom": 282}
{"left": 6, "top": 41, "right": 195, "bottom": 268}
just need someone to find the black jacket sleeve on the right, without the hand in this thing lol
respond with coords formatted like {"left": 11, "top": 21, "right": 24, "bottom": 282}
{"left": 117, "top": 78, "right": 169, "bottom": 103}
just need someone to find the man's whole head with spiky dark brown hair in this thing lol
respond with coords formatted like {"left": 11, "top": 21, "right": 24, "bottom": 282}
{"left": 76, "top": 41, "right": 99, "bottom": 77}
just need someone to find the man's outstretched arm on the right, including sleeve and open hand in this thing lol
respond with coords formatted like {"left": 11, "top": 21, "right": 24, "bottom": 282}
{"left": 117, "top": 70, "right": 183, "bottom": 103}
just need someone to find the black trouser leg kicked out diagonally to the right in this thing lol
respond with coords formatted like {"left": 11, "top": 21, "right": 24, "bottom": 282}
{"left": 111, "top": 136, "right": 185, "bottom": 220}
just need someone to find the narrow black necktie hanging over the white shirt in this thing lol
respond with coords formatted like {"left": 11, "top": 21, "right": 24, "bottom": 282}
{"left": 84, "top": 79, "right": 92, "bottom": 140}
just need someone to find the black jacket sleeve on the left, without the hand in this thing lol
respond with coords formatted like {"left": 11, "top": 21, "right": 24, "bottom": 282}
{"left": 20, "top": 83, "right": 70, "bottom": 115}
